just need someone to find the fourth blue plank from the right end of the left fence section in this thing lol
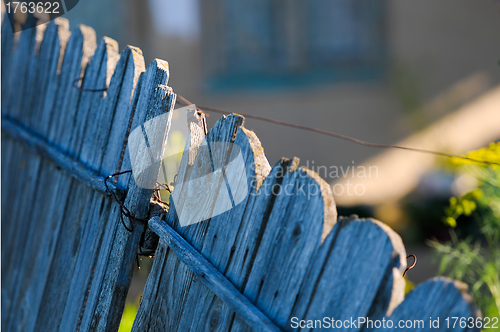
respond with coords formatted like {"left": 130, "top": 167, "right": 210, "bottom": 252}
{"left": 5, "top": 27, "right": 95, "bottom": 330}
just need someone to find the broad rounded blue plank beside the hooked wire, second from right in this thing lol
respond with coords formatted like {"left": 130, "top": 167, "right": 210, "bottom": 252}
{"left": 289, "top": 219, "right": 406, "bottom": 332}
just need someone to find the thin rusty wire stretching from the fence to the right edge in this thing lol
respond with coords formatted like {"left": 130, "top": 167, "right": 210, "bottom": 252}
{"left": 177, "top": 95, "right": 500, "bottom": 166}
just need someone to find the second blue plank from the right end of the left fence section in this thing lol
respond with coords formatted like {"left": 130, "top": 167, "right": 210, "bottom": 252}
{"left": 59, "top": 46, "right": 144, "bottom": 331}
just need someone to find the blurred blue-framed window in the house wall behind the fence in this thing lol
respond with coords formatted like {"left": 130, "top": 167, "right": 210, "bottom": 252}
{"left": 201, "top": 0, "right": 387, "bottom": 89}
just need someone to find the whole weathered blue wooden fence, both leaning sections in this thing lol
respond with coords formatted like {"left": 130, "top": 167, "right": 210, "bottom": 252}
{"left": 1, "top": 13, "right": 480, "bottom": 332}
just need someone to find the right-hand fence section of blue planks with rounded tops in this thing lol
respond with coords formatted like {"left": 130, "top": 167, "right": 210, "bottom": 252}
{"left": 134, "top": 115, "right": 477, "bottom": 331}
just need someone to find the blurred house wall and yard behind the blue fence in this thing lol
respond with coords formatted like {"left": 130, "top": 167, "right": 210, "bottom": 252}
{"left": 57, "top": 0, "right": 500, "bottom": 310}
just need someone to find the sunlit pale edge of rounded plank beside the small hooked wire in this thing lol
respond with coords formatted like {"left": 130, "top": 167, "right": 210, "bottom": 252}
{"left": 368, "top": 218, "right": 407, "bottom": 316}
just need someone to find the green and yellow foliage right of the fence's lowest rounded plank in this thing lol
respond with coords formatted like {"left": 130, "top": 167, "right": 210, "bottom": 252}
{"left": 429, "top": 143, "right": 500, "bottom": 317}
